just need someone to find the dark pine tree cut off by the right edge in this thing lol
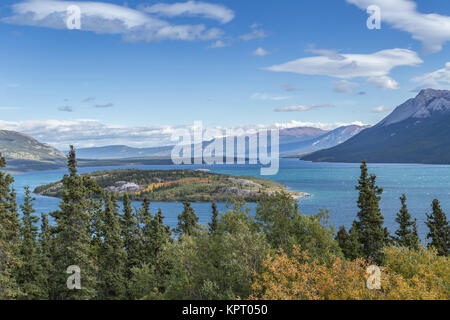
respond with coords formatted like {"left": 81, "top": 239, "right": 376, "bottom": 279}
{"left": 426, "top": 199, "right": 450, "bottom": 256}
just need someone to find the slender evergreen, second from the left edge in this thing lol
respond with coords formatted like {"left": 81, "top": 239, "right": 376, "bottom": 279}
{"left": 17, "top": 187, "right": 43, "bottom": 300}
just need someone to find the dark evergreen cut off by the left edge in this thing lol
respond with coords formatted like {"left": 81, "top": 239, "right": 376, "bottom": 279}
{"left": 0, "top": 153, "right": 21, "bottom": 300}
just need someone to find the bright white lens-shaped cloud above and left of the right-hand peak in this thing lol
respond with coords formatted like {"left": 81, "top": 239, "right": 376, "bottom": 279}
{"left": 267, "top": 49, "right": 423, "bottom": 89}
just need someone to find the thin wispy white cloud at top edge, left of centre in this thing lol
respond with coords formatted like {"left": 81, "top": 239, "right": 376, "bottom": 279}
{"left": 144, "top": 0, "right": 234, "bottom": 23}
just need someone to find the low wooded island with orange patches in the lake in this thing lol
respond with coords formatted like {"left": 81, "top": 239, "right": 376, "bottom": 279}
{"left": 34, "top": 169, "right": 309, "bottom": 202}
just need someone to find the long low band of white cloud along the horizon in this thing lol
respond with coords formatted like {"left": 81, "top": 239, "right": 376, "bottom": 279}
{"left": 0, "top": 119, "right": 362, "bottom": 150}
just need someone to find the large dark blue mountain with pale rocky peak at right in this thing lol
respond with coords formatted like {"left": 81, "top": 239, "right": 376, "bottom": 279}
{"left": 302, "top": 89, "right": 450, "bottom": 164}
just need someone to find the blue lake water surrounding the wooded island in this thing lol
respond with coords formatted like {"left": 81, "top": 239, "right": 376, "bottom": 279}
{"left": 8, "top": 159, "right": 450, "bottom": 239}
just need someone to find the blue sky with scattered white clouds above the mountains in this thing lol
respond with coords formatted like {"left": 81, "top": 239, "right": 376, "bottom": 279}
{"left": 0, "top": 0, "right": 450, "bottom": 150}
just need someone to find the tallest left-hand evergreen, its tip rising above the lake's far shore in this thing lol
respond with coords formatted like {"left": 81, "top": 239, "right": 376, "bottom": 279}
{"left": 51, "top": 146, "right": 101, "bottom": 300}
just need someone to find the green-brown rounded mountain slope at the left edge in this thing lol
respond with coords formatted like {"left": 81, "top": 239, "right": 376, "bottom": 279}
{"left": 0, "top": 130, "right": 66, "bottom": 162}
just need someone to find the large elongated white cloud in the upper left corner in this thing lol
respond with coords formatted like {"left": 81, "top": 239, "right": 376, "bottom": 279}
{"left": 2, "top": 0, "right": 223, "bottom": 42}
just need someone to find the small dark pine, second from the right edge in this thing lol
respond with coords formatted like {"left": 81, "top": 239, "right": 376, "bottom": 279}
{"left": 394, "top": 195, "right": 420, "bottom": 249}
